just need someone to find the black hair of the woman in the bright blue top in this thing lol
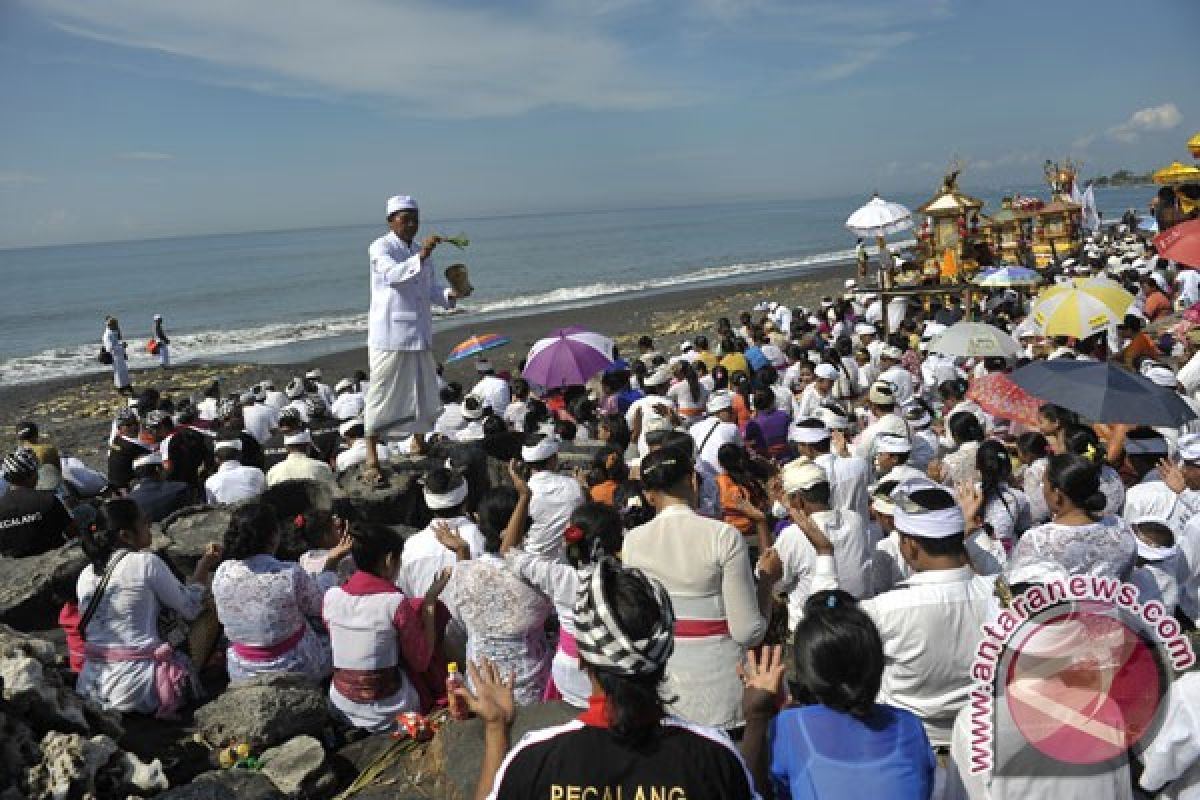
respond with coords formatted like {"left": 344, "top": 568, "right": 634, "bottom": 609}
{"left": 793, "top": 589, "right": 883, "bottom": 720}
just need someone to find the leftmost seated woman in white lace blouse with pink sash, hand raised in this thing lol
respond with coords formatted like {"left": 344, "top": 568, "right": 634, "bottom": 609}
{"left": 76, "top": 498, "right": 221, "bottom": 718}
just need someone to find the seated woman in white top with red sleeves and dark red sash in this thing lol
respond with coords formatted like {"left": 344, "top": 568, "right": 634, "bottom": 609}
{"left": 324, "top": 525, "right": 450, "bottom": 732}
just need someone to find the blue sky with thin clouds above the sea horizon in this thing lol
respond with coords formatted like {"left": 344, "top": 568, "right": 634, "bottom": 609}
{"left": 0, "top": 0, "right": 1200, "bottom": 248}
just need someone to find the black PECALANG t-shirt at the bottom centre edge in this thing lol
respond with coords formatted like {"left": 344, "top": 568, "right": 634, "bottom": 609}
{"left": 494, "top": 711, "right": 757, "bottom": 800}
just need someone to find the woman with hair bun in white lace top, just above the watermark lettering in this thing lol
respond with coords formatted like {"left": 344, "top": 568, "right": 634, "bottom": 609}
{"left": 1006, "top": 453, "right": 1138, "bottom": 584}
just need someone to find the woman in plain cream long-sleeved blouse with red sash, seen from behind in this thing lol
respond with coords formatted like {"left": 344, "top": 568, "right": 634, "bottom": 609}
{"left": 623, "top": 446, "right": 782, "bottom": 729}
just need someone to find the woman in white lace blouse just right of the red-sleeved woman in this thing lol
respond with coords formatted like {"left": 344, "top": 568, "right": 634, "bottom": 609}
{"left": 434, "top": 487, "right": 553, "bottom": 705}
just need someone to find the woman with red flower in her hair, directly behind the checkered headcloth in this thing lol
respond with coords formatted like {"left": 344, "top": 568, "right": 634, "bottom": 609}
{"left": 503, "top": 503, "right": 625, "bottom": 709}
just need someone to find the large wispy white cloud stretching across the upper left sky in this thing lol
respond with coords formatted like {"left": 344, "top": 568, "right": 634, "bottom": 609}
{"left": 31, "top": 0, "right": 690, "bottom": 118}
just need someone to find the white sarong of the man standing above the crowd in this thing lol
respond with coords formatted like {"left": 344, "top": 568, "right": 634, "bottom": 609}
{"left": 362, "top": 348, "right": 442, "bottom": 439}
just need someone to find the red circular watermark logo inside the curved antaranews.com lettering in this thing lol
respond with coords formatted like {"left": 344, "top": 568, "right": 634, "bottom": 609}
{"left": 1004, "top": 602, "right": 1168, "bottom": 764}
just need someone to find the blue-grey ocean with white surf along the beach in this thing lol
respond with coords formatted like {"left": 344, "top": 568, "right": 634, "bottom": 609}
{"left": 0, "top": 186, "right": 1153, "bottom": 385}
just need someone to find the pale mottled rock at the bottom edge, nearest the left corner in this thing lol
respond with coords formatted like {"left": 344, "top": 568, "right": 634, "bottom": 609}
{"left": 26, "top": 732, "right": 168, "bottom": 798}
